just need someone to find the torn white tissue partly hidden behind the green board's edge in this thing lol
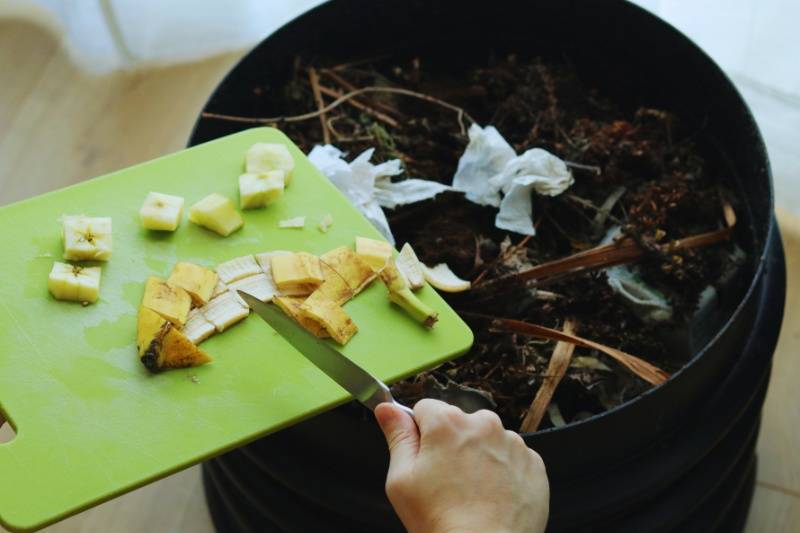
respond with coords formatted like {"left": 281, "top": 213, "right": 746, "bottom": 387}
{"left": 308, "top": 144, "right": 451, "bottom": 244}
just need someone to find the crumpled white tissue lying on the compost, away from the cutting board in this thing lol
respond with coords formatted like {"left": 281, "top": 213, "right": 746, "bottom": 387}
{"left": 453, "top": 124, "right": 575, "bottom": 235}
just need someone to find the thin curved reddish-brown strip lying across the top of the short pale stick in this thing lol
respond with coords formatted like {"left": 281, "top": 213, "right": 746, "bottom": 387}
{"left": 490, "top": 318, "right": 669, "bottom": 385}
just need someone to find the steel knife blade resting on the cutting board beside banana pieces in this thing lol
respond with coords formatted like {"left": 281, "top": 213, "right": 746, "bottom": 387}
{"left": 237, "top": 291, "right": 414, "bottom": 417}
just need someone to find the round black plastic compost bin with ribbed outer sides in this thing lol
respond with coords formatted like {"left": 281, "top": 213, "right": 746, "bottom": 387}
{"left": 190, "top": 0, "right": 785, "bottom": 531}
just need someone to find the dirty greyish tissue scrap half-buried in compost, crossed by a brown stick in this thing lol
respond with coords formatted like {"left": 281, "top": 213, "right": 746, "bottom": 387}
{"left": 600, "top": 226, "right": 672, "bottom": 322}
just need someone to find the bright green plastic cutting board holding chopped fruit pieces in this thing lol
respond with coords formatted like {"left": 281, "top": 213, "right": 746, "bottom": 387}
{"left": 0, "top": 128, "right": 472, "bottom": 530}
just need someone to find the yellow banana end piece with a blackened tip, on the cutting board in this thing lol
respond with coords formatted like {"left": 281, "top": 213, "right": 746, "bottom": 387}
{"left": 136, "top": 307, "right": 211, "bottom": 372}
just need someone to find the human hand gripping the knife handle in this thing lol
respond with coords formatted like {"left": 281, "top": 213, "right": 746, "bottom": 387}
{"left": 375, "top": 399, "right": 550, "bottom": 533}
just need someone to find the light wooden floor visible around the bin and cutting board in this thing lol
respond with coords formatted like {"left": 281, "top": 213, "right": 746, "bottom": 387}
{"left": 0, "top": 18, "right": 800, "bottom": 533}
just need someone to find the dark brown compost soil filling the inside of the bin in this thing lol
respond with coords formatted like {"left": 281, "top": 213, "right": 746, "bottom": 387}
{"left": 248, "top": 55, "right": 736, "bottom": 429}
